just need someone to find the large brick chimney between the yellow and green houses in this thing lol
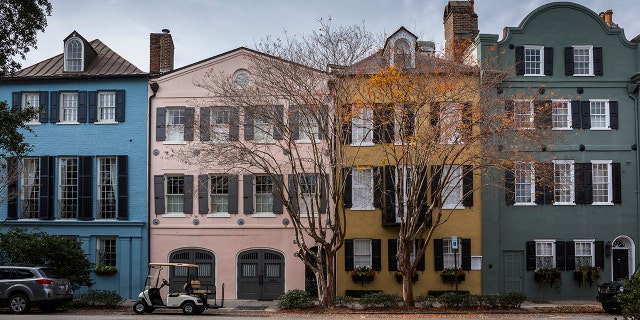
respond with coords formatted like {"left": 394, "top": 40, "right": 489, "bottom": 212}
{"left": 443, "top": 0, "right": 479, "bottom": 62}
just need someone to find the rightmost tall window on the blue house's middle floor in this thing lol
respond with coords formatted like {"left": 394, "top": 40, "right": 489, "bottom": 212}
{"left": 98, "top": 157, "right": 118, "bottom": 219}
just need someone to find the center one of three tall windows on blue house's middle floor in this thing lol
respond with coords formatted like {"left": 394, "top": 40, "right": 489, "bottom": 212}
{"left": 58, "top": 158, "right": 78, "bottom": 219}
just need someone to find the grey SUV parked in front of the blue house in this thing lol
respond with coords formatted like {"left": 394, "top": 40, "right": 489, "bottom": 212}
{"left": 0, "top": 266, "right": 73, "bottom": 313}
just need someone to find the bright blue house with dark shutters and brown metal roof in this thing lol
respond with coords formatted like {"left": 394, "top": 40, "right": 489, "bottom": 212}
{"left": 0, "top": 31, "right": 148, "bottom": 298}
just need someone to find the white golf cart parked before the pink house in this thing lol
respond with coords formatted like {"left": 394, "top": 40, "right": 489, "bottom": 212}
{"left": 133, "top": 263, "right": 224, "bottom": 315}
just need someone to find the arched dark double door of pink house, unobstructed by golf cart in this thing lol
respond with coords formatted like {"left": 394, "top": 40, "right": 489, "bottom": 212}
{"left": 238, "top": 249, "right": 284, "bottom": 300}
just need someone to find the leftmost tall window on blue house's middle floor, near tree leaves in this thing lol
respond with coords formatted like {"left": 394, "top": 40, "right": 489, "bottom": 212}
{"left": 20, "top": 158, "right": 40, "bottom": 219}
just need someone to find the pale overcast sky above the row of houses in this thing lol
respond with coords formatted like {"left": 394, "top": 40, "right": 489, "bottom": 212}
{"left": 17, "top": 0, "right": 640, "bottom": 71}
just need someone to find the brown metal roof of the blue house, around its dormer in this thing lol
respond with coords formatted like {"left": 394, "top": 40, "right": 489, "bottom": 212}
{"left": 4, "top": 39, "right": 148, "bottom": 80}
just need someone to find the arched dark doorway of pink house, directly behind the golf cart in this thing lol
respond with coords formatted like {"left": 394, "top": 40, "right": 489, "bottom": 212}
{"left": 169, "top": 248, "right": 216, "bottom": 292}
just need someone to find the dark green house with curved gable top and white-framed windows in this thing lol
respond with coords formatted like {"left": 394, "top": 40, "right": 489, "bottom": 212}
{"left": 474, "top": 2, "right": 640, "bottom": 300}
